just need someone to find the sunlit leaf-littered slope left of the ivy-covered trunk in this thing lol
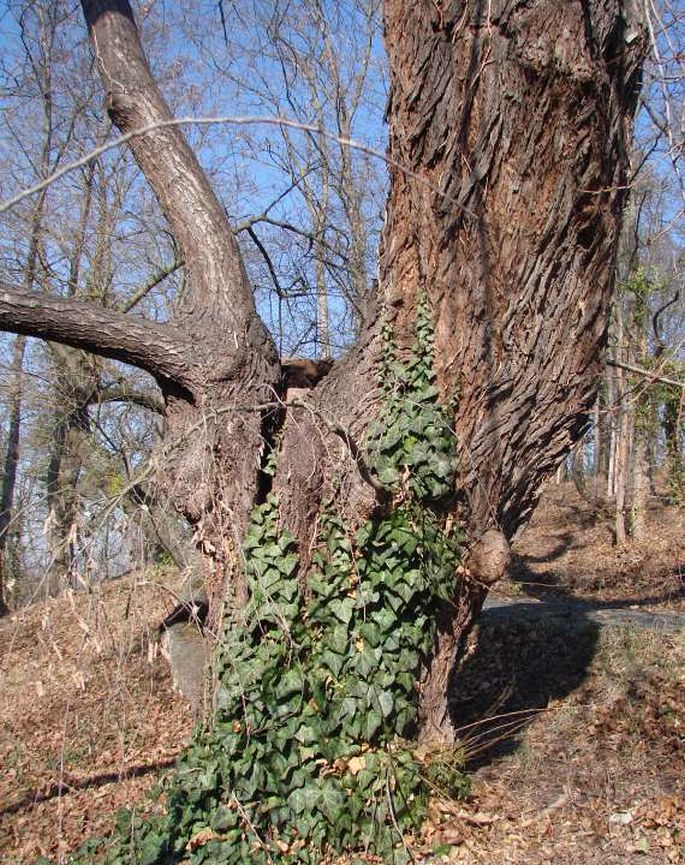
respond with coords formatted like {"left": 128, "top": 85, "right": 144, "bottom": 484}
{"left": 0, "top": 575, "right": 192, "bottom": 863}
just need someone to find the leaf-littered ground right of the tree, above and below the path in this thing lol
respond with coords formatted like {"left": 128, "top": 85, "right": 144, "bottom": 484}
{"left": 429, "top": 484, "right": 685, "bottom": 865}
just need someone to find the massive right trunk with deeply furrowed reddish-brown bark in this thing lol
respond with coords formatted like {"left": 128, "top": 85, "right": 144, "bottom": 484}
{"left": 374, "top": 0, "right": 642, "bottom": 736}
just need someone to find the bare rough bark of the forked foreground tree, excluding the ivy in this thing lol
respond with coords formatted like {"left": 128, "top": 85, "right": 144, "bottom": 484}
{"left": 0, "top": 0, "right": 644, "bottom": 739}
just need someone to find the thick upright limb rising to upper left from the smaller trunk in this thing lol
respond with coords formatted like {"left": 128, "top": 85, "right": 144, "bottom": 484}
{"left": 81, "top": 0, "right": 256, "bottom": 341}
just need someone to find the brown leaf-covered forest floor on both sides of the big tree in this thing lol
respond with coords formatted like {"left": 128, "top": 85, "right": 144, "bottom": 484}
{"left": 0, "top": 484, "right": 685, "bottom": 865}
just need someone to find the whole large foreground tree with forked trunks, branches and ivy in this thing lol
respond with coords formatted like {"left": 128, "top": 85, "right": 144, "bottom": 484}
{"left": 0, "top": 0, "right": 644, "bottom": 862}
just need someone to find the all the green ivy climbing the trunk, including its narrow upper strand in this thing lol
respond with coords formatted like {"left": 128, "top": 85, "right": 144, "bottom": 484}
{"left": 68, "top": 296, "right": 466, "bottom": 865}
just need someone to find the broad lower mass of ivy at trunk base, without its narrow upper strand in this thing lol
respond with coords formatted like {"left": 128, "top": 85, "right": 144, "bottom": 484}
{"left": 160, "top": 500, "right": 464, "bottom": 863}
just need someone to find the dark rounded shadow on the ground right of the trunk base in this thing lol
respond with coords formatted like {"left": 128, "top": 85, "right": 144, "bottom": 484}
{"left": 450, "top": 617, "right": 599, "bottom": 770}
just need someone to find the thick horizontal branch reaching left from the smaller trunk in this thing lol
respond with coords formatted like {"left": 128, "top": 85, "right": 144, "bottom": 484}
{"left": 0, "top": 282, "right": 200, "bottom": 402}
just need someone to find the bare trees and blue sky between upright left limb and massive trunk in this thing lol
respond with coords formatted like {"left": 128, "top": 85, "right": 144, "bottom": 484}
{"left": 180, "top": 0, "right": 387, "bottom": 357}
